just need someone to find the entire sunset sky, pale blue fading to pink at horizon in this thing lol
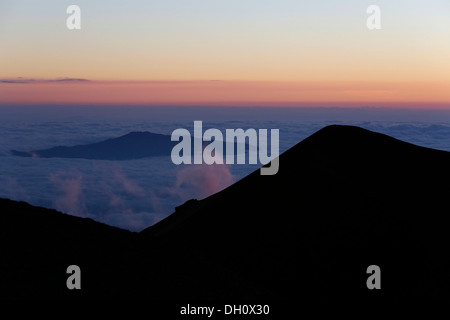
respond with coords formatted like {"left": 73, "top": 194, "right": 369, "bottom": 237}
{"left": 0, "top": 0, "right": 450, "bottom": 109}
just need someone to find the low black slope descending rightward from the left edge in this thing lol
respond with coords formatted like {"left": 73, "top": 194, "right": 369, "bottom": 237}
{"left": 0, "top": 199, "right": 267, "bottom": 300}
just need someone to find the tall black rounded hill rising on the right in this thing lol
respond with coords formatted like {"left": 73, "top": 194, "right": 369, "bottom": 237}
{"left": 142, "top": 126, "right": 450, "bottom": 297}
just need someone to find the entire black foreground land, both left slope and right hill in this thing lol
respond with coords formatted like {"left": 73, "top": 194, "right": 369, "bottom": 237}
{"left": 0, "top": 126, "right": 450, "bottom": 301}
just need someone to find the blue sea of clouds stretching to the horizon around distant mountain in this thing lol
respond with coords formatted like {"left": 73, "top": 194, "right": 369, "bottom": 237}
{"left": 0, "top": 106, "right": 450, "bottom": 231}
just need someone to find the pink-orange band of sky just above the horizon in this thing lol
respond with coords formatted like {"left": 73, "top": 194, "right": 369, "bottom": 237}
{"left": 0, "top": 81, "right": 450, "bottom": 107}
